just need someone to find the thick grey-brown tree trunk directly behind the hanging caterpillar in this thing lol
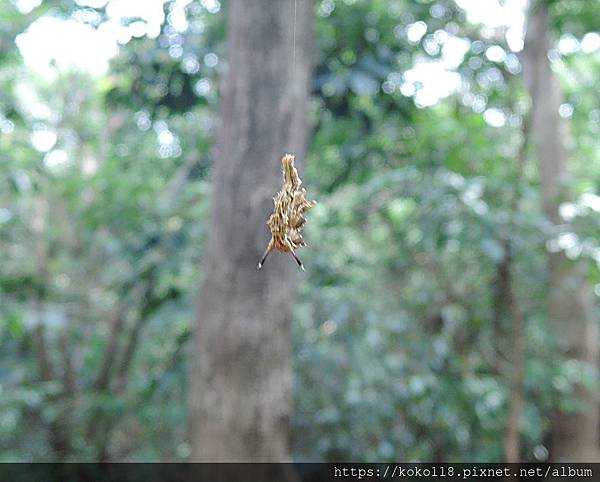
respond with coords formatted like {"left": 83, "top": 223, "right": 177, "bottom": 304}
{"left": 190, "top": 0, "right": 312, "bottom": 462}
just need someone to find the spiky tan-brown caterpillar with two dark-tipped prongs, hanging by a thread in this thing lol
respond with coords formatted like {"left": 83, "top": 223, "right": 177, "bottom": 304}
{"left": 257, "top": 154, "right": 317, "bottom": 270}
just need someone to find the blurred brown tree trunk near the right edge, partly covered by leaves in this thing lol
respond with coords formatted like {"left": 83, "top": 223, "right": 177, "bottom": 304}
{"left": 523, "top": 1, "right": 600, "bottom": 462}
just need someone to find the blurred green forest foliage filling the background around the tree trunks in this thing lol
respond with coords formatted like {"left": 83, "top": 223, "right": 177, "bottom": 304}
{"left": 0, "top": 0, "right": 600, "bottom": 462}
